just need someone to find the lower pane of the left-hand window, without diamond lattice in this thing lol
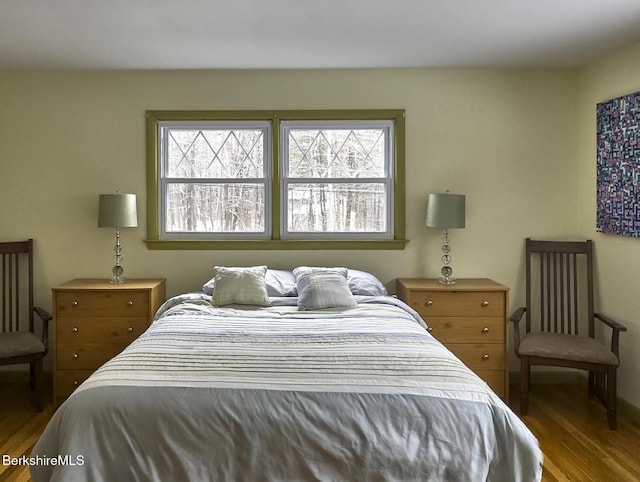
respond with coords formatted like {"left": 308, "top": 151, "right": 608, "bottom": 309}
{"left": 165, "top": 183, "right": 265, "bottom": 233}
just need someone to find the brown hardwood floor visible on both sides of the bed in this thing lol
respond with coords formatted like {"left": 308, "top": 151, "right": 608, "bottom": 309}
{"left": 0, "top": 383, "right": 640, "bottom": 482}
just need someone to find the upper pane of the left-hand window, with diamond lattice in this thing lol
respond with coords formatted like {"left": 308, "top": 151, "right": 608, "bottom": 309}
{"left": 165, "top": 128, "right": 265, "bottom": 179}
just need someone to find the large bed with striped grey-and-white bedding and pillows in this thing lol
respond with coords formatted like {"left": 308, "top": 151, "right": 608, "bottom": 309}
{"left": 30, "top": 267, "right": 542, "bottom": 482}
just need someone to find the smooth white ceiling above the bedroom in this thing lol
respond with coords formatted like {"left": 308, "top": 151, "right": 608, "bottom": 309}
{"left": 0, "top": 0, "right": 640, "bottom": 70}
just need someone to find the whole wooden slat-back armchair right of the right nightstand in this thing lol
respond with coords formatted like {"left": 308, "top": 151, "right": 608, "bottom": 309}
{"left": 511, "top": 238, "right": 627, "bottom": 430}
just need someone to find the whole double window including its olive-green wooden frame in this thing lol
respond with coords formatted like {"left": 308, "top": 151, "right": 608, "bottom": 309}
{"left": 147, "top": 110, "right": 405, "bottom": 249}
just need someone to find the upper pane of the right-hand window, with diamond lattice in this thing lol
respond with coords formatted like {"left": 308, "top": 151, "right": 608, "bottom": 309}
{"left": 288, "top": 128, "right": 386, "bottom": 178}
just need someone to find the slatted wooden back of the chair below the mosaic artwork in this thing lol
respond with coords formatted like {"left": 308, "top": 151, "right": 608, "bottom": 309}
{"left": 526, "top": 239, "right": 593, "bottom": 336}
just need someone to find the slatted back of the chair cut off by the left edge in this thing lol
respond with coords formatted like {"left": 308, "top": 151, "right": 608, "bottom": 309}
{"left": 0, "top": 239, "right": 34, "bottom": 332}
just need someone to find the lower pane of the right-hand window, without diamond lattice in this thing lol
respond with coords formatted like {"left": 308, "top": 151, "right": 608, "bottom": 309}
{"left": 287, "top": 183, "right": 387, "bottom": 233}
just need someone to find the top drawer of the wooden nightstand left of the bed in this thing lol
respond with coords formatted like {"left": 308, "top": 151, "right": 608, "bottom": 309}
{"left": 56, "top": 290, "right": 149, "bottom": 317}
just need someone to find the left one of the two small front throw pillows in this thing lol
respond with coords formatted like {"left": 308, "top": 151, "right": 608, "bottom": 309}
{"left": 211, "top": 266, "right": 270, "bottom": 306}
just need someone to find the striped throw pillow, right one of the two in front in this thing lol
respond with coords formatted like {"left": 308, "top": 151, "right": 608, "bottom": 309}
{"left": 293, "top": 266, "right": 357, "bottom": 310}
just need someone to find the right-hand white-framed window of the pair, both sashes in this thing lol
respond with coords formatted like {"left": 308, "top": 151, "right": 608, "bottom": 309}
{"left": 281, "top": 121, "right": 393, "bottom": 239}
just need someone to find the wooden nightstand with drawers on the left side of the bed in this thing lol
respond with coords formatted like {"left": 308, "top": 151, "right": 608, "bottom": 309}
{"left": 52, "top": 279, "right": 165, "bottom": 406}
